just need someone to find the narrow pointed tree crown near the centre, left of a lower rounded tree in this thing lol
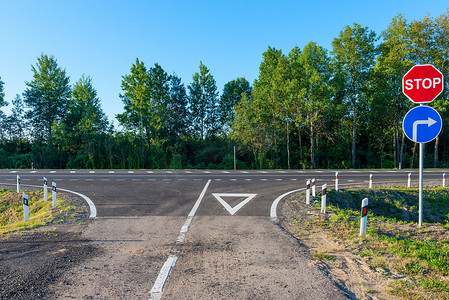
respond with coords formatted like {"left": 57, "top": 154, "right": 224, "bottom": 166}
{"left": 188, "top": 62, "right": 219, "bottom": 140}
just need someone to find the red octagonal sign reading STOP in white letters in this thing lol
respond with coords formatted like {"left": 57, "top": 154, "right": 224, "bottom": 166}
{"left": 402, "top": 65, "right": 443, "bottom": 103}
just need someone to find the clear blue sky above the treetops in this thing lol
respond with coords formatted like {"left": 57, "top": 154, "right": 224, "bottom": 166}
{"left": 0, "top": 0, "right": 449, "bottom": 123}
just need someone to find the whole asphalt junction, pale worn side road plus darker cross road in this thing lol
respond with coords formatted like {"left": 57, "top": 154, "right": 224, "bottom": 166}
{"left": 0, "top": 170, "right": 449, "bottom": 300}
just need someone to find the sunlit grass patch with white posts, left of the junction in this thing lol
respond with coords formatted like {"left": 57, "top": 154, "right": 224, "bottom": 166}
{"left": 0, "top": 189, "right": 75, "bottom": 236}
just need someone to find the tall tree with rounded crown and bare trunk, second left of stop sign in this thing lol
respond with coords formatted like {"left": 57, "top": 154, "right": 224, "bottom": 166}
{"left": 332, "top": 23, "right": 377, "bottom": 168}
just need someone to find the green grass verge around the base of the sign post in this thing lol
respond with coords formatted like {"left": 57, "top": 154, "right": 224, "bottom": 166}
{"left": 300, "top": 187, "right": 449, "bottom": 299}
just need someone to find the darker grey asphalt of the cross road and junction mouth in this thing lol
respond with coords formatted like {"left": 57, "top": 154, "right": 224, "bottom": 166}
{"left": 0, "top": 170, "right": 449, "bottom": 217}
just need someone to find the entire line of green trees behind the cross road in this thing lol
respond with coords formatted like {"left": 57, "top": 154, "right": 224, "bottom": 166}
{"left": 0, "top": 10, "right": 449, "bottom": 169}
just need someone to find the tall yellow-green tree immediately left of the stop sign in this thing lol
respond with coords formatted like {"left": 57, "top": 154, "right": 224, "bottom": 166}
{"left": 368, "top": 15, "right": 413, "bottom": 166}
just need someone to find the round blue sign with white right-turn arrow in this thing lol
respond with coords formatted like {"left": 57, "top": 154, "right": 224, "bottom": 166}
{"left": 402, "top": 105, "right": 443, "bottom": 143}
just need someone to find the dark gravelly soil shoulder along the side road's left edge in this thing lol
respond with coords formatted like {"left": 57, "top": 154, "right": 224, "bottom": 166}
{"left": 0, "top": 189, "right": 101, "bottom": 299}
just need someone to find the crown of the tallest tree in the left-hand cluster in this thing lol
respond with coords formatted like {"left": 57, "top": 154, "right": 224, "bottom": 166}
{"left": 23, "top": 54, "right": 70, "bottom": 138}
